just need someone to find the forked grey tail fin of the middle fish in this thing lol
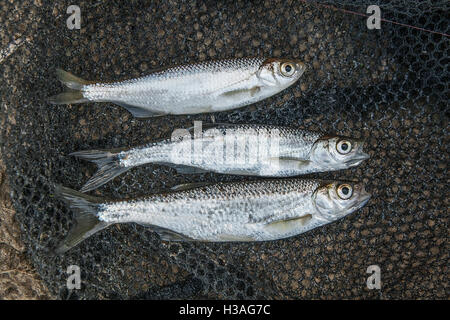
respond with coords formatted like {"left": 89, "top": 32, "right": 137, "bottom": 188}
{"left": 70, "top": 150, "right": 130, "bottom": 192}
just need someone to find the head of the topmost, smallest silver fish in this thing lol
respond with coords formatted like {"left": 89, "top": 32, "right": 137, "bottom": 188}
{"left": 257, "top": 59, "right": 306, "bottom": 88}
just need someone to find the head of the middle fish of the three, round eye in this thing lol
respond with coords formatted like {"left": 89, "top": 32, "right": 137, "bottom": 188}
{"left": 309, "top": 136, "right": 370, "bottom": 170}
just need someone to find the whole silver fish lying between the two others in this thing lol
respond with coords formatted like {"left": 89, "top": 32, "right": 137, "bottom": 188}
{"left": 70, "top": 121, "right": 369, "bottom": 192}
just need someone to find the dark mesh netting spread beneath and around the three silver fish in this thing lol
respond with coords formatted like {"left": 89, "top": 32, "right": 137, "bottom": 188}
{"left": 0, "top": 0, "right": 449, "bottom": 299}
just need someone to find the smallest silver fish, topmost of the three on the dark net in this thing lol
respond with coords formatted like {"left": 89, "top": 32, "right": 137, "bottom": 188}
{"left": 48, "top": 57, "right": 306, "bottom": 118}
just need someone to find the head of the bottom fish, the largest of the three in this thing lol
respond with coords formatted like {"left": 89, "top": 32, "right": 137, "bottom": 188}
{"left": 313, "top": 181, "right": 371, "bottom": 222}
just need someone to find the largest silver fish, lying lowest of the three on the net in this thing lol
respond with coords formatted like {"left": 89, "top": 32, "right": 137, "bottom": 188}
{"left": 54, "top": 178, "right": 371, "bottom": 254}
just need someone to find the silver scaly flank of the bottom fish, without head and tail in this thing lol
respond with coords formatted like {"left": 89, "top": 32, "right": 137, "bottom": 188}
{"left": 99, "top": 179, "right": 320, "bottom": 241}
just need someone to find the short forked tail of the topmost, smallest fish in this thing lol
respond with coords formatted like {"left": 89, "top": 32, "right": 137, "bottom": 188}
{"left": 48, "top": 69, "right": 93, "bottom": 104}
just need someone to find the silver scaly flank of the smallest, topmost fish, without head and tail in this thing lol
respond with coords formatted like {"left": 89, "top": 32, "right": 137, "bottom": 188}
{"left": 83, "top": 58, "right": 266, "bottom": 111}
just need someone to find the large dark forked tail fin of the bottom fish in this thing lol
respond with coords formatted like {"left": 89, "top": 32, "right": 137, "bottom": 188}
{"left": 55, "top": 185, "right": 110, "bottom": 254}
